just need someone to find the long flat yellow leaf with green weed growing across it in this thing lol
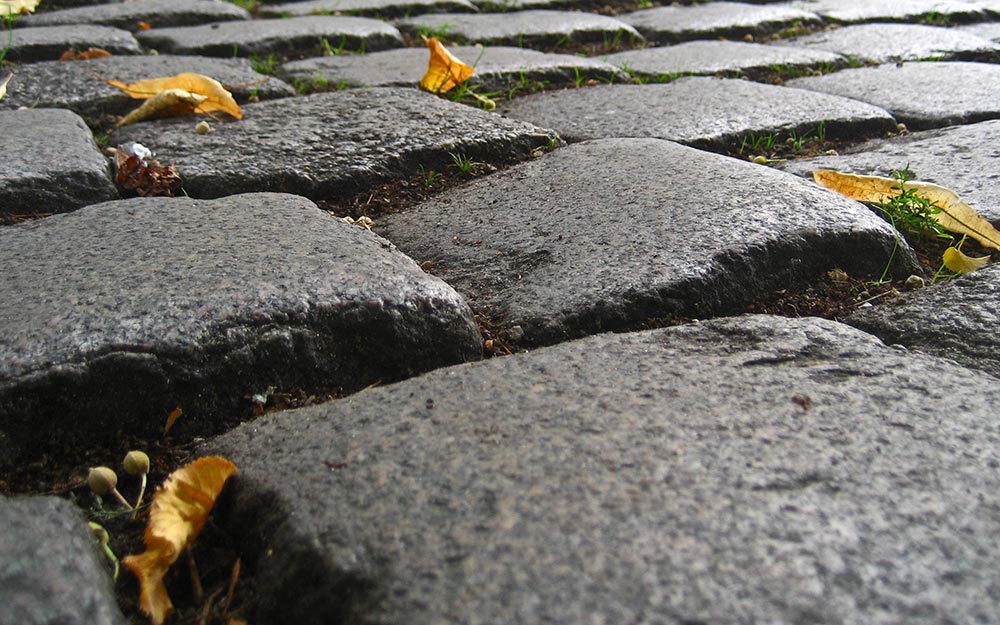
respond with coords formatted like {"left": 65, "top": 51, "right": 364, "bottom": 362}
{"left": 813, "top": 169, "right": 1000, "bottom": 250}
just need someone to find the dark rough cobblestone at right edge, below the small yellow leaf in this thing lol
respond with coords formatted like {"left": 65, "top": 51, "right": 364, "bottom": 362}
{"left": 848, "top": 265, "right": 1000, "bottom": 376}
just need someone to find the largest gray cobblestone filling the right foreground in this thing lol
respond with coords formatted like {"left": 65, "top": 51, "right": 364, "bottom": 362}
{"left": 209, "top": 316, "right": 1000, "bottom": 625}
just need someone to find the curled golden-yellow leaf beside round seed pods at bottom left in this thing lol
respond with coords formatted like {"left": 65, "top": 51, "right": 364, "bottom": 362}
{"left": 122, "top": 456, "right": 236, "bottom": 625}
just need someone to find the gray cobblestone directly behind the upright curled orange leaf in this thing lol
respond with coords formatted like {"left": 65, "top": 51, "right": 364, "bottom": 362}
{"left": 281, "top": 46, "right": 628, "bottom": 91}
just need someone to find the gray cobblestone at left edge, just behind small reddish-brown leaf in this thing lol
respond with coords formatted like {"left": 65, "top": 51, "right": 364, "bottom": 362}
{"left": 4, "top": 24, "right": 141, "bottom": 62}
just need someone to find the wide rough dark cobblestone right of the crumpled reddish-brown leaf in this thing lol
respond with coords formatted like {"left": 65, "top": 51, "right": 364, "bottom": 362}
{"left": 111, "top": 87, "right": 554, "bottom": 200}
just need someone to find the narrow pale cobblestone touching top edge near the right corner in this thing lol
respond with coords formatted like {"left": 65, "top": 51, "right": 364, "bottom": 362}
{"left": 792, "top": 0, "right": 986, "bottom": 23}
